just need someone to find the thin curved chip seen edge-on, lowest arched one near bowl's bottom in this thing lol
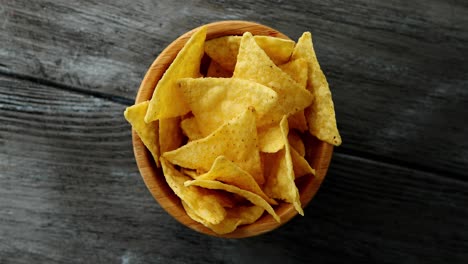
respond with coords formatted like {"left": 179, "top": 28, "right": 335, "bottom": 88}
{"left": 185, "top": 179, "right": 281, "bottom": 222}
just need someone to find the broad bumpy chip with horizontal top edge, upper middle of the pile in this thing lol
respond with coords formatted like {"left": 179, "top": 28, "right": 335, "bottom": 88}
{"left": 179, "top": 78, "right": 278, "bottom": 136}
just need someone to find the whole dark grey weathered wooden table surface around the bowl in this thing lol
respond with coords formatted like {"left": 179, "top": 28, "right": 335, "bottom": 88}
{"left": 0, "top": 0, "right": 468, "bottom": 263}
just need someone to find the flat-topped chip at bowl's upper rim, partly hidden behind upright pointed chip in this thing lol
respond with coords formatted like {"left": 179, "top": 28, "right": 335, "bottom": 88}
{"left": 205, "top": 36, "right": 294, "bottom": 72}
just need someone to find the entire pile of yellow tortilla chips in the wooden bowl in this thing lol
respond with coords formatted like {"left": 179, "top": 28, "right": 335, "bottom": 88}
{"left": 124, "top": 27, "right": 341, "bottom": 234}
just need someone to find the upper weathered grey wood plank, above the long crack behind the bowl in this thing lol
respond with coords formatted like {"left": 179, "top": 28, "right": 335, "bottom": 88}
{"left": 0, "top": 0, "right": 468, "bottom": 178}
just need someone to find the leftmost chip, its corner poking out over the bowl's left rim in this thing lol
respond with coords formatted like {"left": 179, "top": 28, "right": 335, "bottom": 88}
{"left": 124, "top": 101, "right": 160, "bottom": 167}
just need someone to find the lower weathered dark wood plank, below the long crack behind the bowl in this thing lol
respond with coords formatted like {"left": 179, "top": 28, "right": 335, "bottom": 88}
{"left": 0, "top": 77, "right": 468, "bottom": 263}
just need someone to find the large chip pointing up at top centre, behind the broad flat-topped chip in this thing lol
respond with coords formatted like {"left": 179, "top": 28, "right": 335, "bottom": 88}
{"left": 233, "top": 32, "right": 312, "bottom": 126}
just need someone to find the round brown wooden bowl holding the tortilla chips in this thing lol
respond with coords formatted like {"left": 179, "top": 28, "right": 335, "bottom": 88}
{"left": 132, "top": 21, "right": 333, "bottom": 238}
